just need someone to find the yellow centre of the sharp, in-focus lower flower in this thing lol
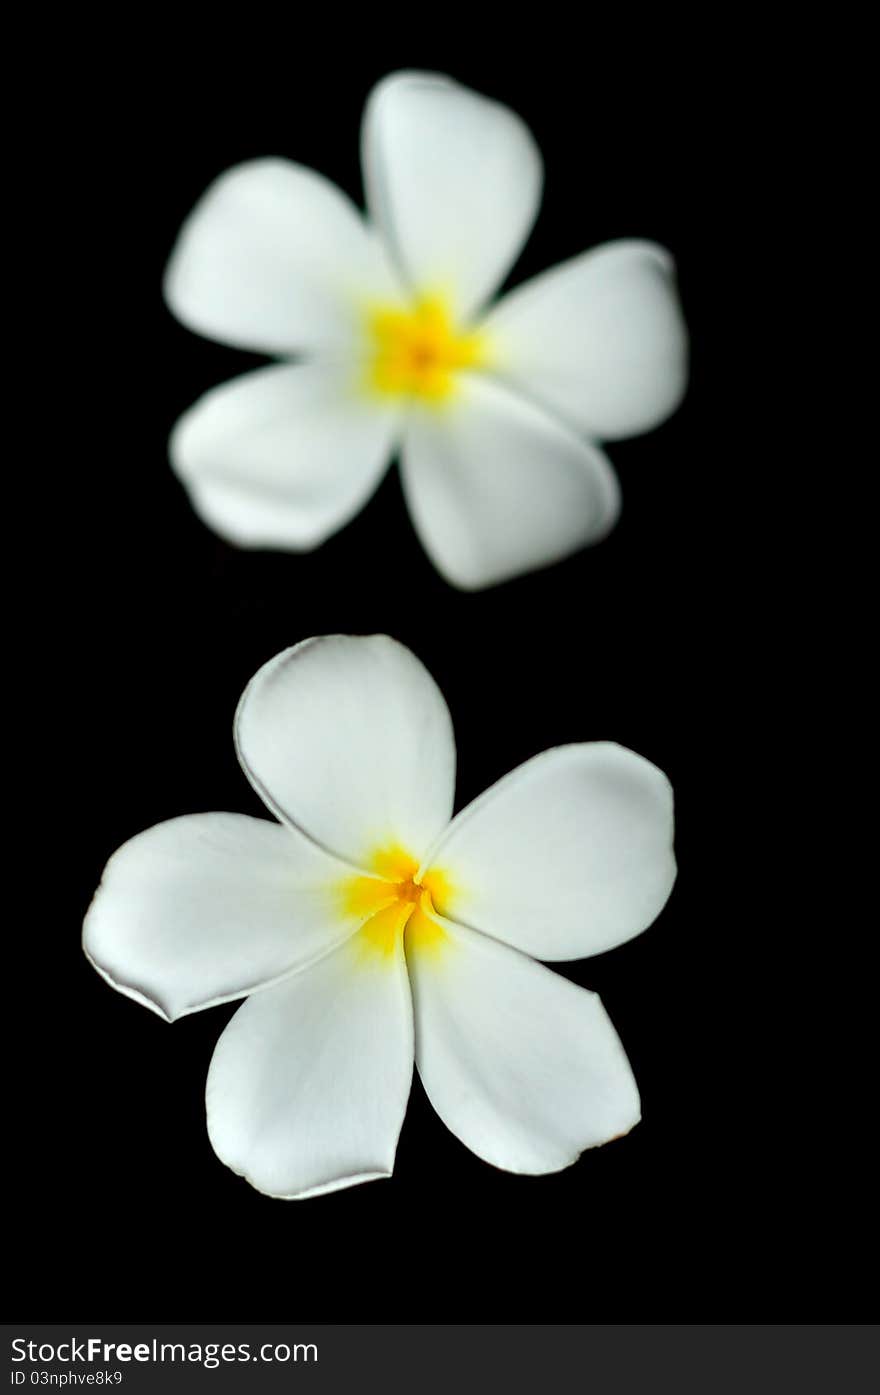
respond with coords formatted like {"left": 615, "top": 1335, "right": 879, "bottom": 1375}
{"left": 340, "top": 847, "right": 450, "bottom": 957}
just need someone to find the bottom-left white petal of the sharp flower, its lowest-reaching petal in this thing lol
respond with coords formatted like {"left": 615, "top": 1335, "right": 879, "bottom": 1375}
{"left": 206, "top": 942, "right": 413, "bottom": 1197}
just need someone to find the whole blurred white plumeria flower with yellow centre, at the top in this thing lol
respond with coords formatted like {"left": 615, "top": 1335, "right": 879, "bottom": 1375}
{"left": 165, "top": 73, "right": 686, "bottom": 590}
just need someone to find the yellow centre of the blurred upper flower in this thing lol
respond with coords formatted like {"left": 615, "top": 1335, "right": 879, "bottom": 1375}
{"left": 367, "top": 296, "right": 488, "bottom": 406}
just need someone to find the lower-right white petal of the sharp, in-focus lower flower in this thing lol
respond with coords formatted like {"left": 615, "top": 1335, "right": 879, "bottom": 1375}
{"left": 407, "top": 922, "right": 639, "bottom": 1173}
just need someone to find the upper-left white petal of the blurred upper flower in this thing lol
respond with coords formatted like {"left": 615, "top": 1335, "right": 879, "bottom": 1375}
{"left": 165, "top": 159, "right": 399, "bottom": 354}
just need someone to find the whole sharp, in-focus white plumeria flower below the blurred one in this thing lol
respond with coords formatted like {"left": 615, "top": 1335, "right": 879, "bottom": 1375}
{"left": 84, "top": 635, "right": 675, "bottom": 1197}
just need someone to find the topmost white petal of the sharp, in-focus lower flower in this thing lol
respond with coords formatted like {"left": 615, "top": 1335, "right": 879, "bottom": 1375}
{"left": 236, "top": 635, "right": 455, "bottom": 866}
